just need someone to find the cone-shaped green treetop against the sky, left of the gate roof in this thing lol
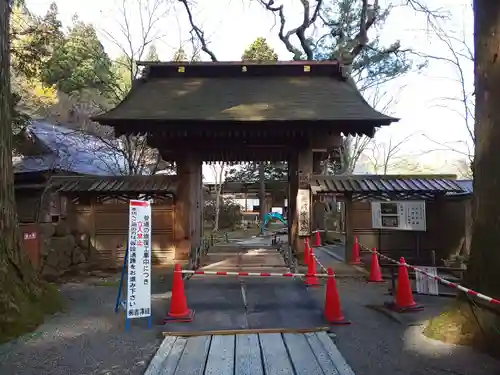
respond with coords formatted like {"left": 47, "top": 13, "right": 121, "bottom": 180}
{"left": 41, "top": 17, "right": 112, "bottom": 95}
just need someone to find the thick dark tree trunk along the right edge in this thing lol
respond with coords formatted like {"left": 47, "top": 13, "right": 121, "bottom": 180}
{"left": 466, "top": 0, "right": 500, "bottom": 298}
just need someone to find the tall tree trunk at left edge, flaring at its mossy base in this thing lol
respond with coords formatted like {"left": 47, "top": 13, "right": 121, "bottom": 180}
{"left": 0, "top": 0, "right": 47, "bottom": 341}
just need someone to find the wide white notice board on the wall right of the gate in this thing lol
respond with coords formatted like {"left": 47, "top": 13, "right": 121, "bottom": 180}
{"left": 371, "top": 201, "right": 427, "bottom": 231}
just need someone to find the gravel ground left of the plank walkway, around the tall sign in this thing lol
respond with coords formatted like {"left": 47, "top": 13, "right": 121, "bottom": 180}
{"left": 0, "top": 283, "right": 170, "bottom": 375}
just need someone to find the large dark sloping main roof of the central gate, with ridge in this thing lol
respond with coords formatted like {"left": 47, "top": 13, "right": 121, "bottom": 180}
{"left": 94, "top": 61, "right": 397, "bottom": 126}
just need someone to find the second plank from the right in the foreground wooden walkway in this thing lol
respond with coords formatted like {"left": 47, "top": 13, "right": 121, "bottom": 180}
{"left": 283, "top": 333, "right": 323, "bottom": 375}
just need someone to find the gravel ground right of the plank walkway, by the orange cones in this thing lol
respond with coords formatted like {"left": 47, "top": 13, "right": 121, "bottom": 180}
{"left": 314, "top": 252, "right": 500, "bottom": 375}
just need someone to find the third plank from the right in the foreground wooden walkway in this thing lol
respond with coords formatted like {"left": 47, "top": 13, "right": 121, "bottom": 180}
{"left": 259, "top": 333, "right": 294, "bottom": 375}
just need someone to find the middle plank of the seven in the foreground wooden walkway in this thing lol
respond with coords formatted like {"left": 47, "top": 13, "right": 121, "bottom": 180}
{"left": 234, "top": 334, "right": 264, "bottom": 375}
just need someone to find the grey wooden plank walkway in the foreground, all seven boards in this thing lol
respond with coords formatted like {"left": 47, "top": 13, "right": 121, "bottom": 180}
{"left": 144, "top": 332, "right": 354, "bottom": 375}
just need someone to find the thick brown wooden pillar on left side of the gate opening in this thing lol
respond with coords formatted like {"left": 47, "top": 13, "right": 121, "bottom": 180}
{"left": 175, "top": 154, "right": 202, "bottom": 260}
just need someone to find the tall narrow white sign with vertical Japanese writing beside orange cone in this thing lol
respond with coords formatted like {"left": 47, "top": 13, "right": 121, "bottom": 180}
{"left": 127, "top": 200, "right": 151, "bottom": 319}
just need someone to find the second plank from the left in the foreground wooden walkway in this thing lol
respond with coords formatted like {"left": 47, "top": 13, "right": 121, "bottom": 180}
{"left": 175, "top": 336, "right": 211, "bottom": 375}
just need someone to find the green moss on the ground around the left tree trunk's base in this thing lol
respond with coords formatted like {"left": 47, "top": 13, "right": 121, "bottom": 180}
{"left": 0, "top": 283, "right": 64, "bottom": 343}
